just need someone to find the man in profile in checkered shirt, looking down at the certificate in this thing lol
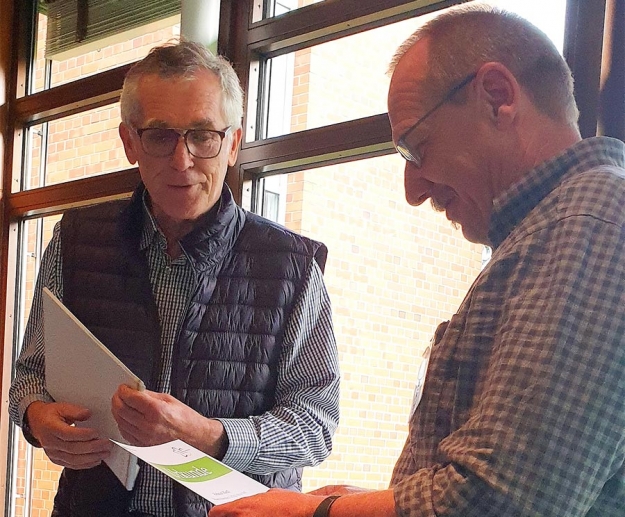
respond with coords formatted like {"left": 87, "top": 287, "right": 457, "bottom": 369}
{"left": 210, "top": 6, "right": 625, "bottom": 517}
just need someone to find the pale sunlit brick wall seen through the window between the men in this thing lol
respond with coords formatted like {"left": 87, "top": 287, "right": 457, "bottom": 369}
{"left": 286, "top": 13, "right": 482, "bottom": 490}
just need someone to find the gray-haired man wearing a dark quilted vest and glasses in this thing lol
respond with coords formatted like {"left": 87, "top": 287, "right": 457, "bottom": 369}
{"left": 10, "top": 42, "right": 339, "bottom": 517}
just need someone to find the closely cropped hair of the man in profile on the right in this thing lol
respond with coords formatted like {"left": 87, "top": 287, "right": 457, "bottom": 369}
{"left": 389, "top": 4, "right": 579, "bottom": 127}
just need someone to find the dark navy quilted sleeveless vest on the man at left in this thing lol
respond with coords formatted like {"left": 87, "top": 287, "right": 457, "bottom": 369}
{"left": 53, "top": 185, "right": 327, "bottom": 517}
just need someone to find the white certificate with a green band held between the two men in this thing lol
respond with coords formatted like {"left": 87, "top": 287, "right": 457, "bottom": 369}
{"left": 112, "top": 440, "right": 269, "bottom": 505}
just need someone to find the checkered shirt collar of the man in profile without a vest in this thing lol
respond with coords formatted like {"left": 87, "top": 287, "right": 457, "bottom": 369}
{"left": 488, "top": 137, "right": 625, "bottom": 248}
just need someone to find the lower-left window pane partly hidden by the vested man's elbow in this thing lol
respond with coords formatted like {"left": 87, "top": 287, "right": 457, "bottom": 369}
{"left": 10, "top": 215, "right": 61, "bottom": 517}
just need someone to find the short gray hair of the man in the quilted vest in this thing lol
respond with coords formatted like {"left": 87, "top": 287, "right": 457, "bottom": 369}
{"left": 120, "top": 41, "right": 243, "bottom": 129}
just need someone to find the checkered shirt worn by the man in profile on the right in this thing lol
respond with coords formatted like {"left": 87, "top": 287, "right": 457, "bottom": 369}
{"left": 391, "top": 138, "right": 625, "bottom": 517}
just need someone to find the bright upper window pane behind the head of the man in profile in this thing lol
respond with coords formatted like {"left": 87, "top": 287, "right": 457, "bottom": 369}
{"left": 252, "top": 0, "right": 566, "bottom": 141}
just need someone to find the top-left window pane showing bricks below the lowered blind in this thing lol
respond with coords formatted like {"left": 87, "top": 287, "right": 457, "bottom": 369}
{"left": 31, "top": 14, "right": 180, "bottom": 93}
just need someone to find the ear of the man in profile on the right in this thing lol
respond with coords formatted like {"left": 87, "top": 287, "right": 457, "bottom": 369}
{"left": 476, "top": 62, "right": 521, "bottom": 128}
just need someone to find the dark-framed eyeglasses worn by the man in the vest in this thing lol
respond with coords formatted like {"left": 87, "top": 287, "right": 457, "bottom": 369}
{"left": 135, "top": 126, "right": 232, "bottom": 159}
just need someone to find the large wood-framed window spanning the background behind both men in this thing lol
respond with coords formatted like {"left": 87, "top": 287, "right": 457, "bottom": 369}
{"left": 0, "top": 0, "right": 611, "bottom": 510}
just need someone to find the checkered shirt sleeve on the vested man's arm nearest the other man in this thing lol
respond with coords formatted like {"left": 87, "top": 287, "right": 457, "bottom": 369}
{"left": 220, "top": 261, "right": 339, "bottom": 474}
